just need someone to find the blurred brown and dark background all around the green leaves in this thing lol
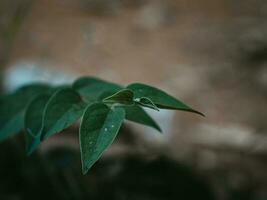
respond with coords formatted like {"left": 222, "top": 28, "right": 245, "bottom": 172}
{"left": 0, "top": 0, "right": 267, "bottom": 200}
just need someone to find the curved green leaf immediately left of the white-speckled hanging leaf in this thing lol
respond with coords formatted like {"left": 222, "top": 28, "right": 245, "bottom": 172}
{"left": 41, "top": 88, "right": 86, "bottom": 140}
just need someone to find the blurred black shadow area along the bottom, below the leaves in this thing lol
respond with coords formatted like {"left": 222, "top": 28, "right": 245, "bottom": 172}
{"left": 0, "top": 136, "right": 214, "bottom": 200}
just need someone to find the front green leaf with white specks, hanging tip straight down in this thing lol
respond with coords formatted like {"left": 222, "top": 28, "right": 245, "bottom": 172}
{"left": 80, "top": 103, "right": 125, "bottom": 174}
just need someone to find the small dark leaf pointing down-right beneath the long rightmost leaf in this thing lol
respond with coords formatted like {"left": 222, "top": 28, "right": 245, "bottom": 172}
{"left": 123, "top": 105, "right": 162, "bottom": 132}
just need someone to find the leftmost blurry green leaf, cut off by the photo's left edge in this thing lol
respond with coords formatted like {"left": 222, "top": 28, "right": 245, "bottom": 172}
{"left": 0, "top": 84, "right": 50, "bottom": 141}
